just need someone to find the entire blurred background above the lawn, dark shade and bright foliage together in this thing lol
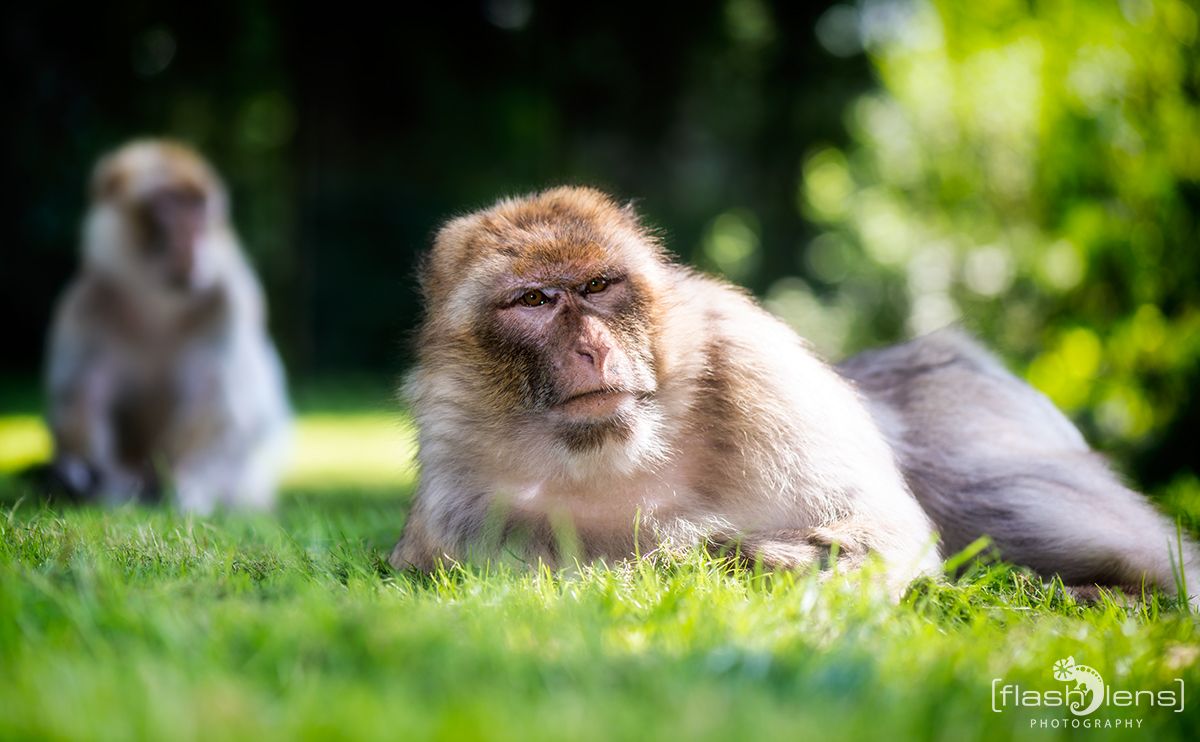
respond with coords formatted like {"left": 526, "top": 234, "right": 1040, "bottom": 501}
{"left": 0, "top": 0, "right": 1200, "bottom": 489}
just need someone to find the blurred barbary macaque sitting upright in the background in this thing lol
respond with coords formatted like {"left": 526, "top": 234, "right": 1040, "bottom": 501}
{"left": 46, "top": 139, "right": 290, "bottom": 513}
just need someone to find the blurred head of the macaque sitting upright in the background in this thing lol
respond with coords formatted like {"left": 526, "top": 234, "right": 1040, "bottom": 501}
{"left": 84, "top": 139, "right": 234, "bottom": 293}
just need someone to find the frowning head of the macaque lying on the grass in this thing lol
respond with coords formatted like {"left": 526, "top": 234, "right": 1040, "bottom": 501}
{"left": 420, "top": 187, "right": 666, "bottom": 461}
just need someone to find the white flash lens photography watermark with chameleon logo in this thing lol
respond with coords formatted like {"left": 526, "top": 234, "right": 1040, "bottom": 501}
{"left": 991, "top": 657, "right": 1186, "bottom": 729}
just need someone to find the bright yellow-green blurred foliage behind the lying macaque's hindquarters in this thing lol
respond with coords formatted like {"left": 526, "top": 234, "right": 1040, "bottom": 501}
{"left": 772, "top": 0, "right": 1200, "bottom": 477}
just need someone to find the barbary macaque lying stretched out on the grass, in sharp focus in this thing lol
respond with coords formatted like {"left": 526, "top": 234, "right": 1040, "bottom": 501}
{"left": 391, "top": 187, "right": 1200, "bottom": 593}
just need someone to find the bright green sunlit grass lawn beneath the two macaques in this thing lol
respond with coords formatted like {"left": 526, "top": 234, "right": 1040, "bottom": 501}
{"left": 0, "top": 384, "right": 1200, "bottom": 740}
